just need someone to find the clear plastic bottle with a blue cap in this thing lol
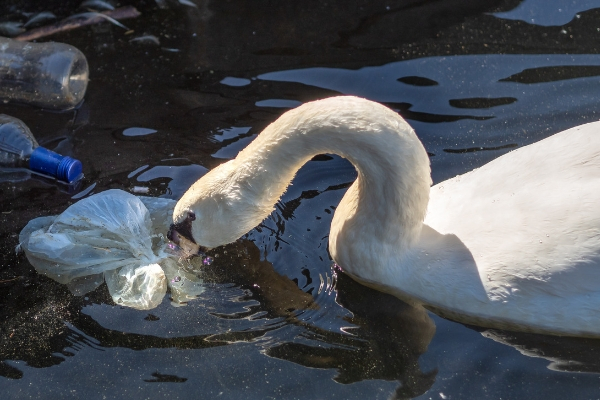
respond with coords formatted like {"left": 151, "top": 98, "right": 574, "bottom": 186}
{"left": 0, "top": 114, "right": 82, "bottom": 183}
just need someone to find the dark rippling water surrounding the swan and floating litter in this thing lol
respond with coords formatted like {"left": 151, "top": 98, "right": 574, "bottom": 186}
{"left": 0, "top": 0, "right": 600, "bottom": 399}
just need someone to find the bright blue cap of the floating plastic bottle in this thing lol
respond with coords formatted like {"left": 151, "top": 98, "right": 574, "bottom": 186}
{"left": 29, "top": 147, "right": 83, "bottom": 183}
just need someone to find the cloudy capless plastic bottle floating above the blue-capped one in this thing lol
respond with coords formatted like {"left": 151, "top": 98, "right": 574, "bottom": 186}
{"left": 0, "top": 37, "right": 89, "bottom": 110}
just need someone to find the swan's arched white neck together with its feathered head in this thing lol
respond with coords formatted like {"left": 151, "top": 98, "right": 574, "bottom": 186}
{"left": 175, "top": 97, "right": 431, "bottom": 272}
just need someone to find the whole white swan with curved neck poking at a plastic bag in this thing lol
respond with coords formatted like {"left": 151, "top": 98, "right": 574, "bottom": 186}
{"left": 168, "top": 96, "right": 600, "bottom": 337}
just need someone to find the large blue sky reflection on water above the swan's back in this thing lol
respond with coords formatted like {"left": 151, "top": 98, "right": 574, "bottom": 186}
{"left": 258, "top": 54, "right": 600, "bottom": 182}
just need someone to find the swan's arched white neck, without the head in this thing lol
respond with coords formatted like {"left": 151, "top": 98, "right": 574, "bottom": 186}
{"left": 236, "top": 98, "right": 431, "bottom": 256}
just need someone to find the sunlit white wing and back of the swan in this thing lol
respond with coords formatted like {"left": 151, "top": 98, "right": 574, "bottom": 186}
{"left": 425, "top": 122, "right": 600, "bottom": 300}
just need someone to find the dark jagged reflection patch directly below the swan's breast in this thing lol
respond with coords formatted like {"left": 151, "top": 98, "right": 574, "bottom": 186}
{"left": 266, "top": 272, "right": 437, "bottom": 398}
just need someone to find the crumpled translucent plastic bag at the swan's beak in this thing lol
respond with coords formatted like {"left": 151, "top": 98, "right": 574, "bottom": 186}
{"left": 19, "top": 189, "right": 203, "bottom": 310}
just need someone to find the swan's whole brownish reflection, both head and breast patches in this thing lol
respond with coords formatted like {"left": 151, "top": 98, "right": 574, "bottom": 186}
{"left": 199, "top": 242, "right": 437, "bottom": 398}
